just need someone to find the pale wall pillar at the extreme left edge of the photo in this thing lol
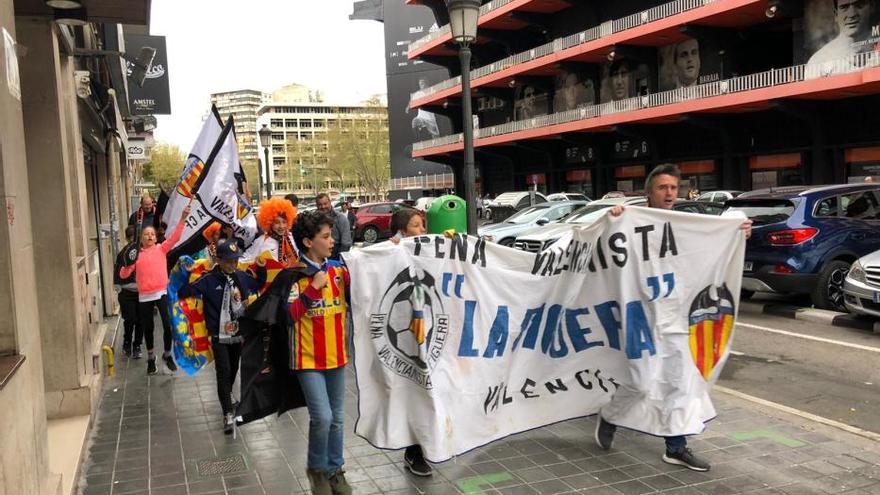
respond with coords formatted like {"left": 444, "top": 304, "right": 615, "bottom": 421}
{"left": 0, "top": 6, "right": 61, "bottom": 495}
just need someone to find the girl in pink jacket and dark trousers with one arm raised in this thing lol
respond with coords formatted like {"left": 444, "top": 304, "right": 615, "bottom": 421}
{"left": 119, "top": 205, "right": 189, "bottom": 375}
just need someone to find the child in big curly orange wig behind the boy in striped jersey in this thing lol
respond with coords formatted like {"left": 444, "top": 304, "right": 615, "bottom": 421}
{"left": 241, "top": 198, "right": 299, "bottom": 266}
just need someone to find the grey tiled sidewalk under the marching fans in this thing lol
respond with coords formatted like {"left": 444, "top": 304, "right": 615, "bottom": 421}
{"left": 78, "top": 348, "right": 880, "bottom": 495}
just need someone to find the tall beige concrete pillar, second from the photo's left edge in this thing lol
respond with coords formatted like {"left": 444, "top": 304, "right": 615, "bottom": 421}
{"left": 18, "top": 18, "right": 98, "bottom": 418}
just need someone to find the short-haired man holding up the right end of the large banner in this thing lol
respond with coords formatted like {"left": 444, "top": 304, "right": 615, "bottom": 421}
{"left": 594, "top": 163, "right": 752, "bottom": 471}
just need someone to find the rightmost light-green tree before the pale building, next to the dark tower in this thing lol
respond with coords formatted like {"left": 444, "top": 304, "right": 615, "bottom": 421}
{"left": 327, "top": 97, "right": 391, "bottom": 198}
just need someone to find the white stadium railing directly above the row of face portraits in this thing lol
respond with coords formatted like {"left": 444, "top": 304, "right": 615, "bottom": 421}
{"left": 410, "top": 0, "right": 723, "bottom": 100}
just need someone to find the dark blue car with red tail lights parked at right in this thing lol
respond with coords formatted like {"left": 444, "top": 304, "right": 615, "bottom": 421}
{"left": 725, "top": 184, "right": 880, "bottom": 311}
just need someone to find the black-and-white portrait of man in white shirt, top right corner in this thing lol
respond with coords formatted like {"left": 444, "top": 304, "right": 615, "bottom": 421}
{"left": 794, "top": 0, "right": 880, "bottom": 64}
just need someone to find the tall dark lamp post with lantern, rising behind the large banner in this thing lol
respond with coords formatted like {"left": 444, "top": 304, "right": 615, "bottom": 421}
{"left": 447, "top": 0, "right": 480, "bottom": 235}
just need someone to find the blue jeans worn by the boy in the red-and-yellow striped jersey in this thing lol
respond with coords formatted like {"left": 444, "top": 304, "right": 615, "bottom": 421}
{"left": 296, "top": 367, "right": 345, "bottom": 476}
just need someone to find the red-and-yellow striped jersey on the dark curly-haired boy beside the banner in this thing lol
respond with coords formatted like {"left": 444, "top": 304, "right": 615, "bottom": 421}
{"left": 288, "top": 260, "right": 349, "bottom": 370}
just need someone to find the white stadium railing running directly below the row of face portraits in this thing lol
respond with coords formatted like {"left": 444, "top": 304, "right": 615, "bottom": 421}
{"left": 413, "top": 52, "right": 880, "bottom": 151}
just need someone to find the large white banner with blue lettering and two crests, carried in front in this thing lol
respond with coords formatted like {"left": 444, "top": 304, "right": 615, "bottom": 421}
{"left": 345, "top": 207, "right": 745, "bottom": 462}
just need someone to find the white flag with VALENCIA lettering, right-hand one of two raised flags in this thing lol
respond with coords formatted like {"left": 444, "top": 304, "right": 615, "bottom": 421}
{"left": 195, "top": 119, "right": 257, "bottom": 246}
